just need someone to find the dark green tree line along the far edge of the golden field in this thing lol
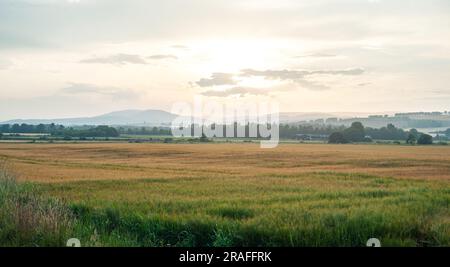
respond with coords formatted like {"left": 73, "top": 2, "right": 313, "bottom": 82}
{"left": 0, "top": 122, "right": 450, "bottom": 143}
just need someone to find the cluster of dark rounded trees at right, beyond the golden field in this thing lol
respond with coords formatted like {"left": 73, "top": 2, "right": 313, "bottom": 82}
{"left": 328, "top": 122, "right": 433, "bottom": 145}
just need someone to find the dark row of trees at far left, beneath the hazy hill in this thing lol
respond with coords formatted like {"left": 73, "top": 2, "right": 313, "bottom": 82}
{"left": 0, "top": 123, "right": 119, "bottom": 138}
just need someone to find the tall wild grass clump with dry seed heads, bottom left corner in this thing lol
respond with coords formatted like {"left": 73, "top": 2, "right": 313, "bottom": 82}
{"left": 0, "top": 164, "right": 73, "bottom": 247}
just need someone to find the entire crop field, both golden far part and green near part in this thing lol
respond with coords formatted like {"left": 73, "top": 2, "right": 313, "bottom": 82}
{"left": 0, "top": 143, "right": 450, "bottom": 246}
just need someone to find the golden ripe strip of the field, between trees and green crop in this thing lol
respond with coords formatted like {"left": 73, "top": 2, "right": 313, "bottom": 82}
{"left": 0, "top": 143, "right": 450, "bottom": 182}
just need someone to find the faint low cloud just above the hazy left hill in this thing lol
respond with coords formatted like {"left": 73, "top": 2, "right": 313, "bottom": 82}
{"left": 60, "top": 83, "right": 138, "bottom": 99}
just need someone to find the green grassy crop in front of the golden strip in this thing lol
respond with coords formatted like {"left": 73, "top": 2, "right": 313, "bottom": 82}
{"left": 35, "top": 172, "right": 450, "bottom": 246}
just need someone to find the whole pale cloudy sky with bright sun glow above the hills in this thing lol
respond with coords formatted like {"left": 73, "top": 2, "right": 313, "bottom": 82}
{"left": 0, "top": 0, "right": 450, "bottom": 120}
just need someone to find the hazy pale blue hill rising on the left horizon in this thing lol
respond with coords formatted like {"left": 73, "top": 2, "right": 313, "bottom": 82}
{"left": 1, "top": 109, "right": 177, "bottom": 126}
